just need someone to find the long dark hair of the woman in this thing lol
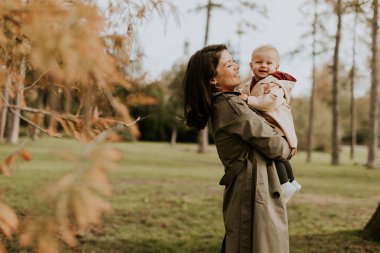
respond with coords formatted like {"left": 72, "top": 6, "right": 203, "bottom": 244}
{"left": 183, "top": 44, "right": 227, "bottom": 130}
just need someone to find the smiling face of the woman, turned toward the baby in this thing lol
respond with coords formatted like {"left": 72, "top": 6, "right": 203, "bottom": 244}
{"left": 214, "top": 50, "right": 241, "bottom": 92}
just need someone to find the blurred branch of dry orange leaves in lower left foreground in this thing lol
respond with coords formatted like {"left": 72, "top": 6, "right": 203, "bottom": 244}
{"left": 15, "top": 129, "right": 122, "bottom": 253}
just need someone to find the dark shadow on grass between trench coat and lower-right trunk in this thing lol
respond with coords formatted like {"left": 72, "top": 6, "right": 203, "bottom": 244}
{"left": 290, "top": 230, "right": 380, "bottom": 253}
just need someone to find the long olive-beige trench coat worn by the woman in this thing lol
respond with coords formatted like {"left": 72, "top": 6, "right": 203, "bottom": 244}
{"left": 211, "top": 92, "right": 292, "bottom": 253}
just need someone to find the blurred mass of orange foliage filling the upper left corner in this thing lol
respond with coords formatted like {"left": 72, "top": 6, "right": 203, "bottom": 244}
{"left": 0, "top": 0, "right": 138, "bottom": 140}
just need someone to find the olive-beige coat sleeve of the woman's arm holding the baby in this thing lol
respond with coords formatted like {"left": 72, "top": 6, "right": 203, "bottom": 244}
{"left": 226, "top": 103, "right": 293, "bottom": 160}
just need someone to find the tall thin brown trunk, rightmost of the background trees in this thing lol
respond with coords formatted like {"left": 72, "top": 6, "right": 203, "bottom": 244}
{"left": 366, "top": 0, "right": 379, "bottom": 169}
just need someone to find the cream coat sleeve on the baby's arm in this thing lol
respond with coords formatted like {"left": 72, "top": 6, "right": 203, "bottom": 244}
{"left": 247, "top": 85, "right": 286, "bottom": 112}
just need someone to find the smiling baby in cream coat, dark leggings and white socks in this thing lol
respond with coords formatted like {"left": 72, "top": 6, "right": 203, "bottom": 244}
{"left": 238, "top": 45, "right": 301, "bottom": 202}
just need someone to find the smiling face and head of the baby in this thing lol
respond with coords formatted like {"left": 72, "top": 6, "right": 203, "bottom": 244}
{"left": 249, "top": 49, "right": 278, "bottom": 80}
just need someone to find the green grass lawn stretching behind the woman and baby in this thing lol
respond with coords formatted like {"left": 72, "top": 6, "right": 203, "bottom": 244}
{"left": 0, "top": 138, "right": 380, "bottom": 253}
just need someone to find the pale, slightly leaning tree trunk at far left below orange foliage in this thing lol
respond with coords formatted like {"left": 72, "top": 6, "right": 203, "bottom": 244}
{"left": 9, "top": 57, "right": 26, "bottom": 144}
